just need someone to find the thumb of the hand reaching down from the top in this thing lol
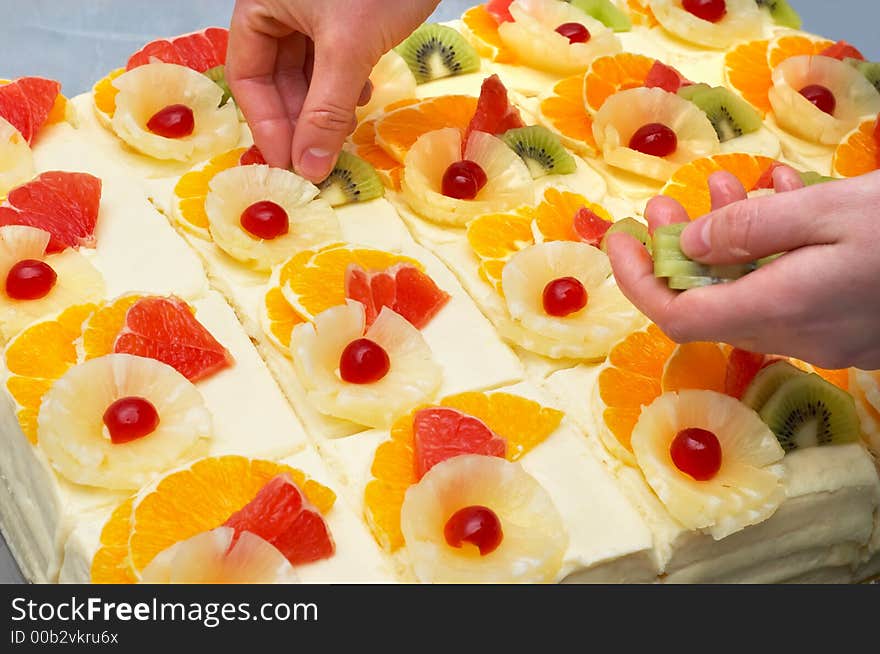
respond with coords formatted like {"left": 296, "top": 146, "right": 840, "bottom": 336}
{"left": 292, "top": 36, "right": 371, "bottom": 182}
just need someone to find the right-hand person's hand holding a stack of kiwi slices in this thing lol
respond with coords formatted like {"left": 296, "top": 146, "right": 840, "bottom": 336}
{"left": 609, "top": 167, "right": 880, "bottom": 369}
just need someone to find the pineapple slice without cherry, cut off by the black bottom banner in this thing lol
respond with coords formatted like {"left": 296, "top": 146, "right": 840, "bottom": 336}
{"left": 140, "top": 527, "right": 299, "bottom": 584}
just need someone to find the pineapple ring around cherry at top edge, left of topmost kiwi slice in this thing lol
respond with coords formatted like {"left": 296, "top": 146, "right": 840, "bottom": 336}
{"left": 498, "top": 0, "right": 622, "bottom": 76}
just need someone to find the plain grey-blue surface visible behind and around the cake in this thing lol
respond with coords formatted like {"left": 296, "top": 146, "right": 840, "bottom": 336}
{"left": 0, "top": 0, "right": 880, "bottom": 583}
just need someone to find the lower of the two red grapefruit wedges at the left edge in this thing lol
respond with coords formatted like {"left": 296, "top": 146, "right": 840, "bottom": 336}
{"left": 0, "top": 171, "right": 101, "bottom": 254}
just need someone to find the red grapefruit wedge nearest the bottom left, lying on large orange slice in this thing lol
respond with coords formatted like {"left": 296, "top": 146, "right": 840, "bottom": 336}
{"left": 224, "top": 474, "right": 336, "bottom": 565}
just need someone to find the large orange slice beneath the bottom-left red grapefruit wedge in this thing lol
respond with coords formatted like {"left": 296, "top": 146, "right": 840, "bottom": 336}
{"left": 128, "top": 456, "right": 336, "bottom": 572}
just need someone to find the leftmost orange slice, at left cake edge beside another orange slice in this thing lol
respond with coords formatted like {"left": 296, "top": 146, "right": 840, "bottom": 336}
{"left": 5, "top": 304, "right": 97, "bottom": 443}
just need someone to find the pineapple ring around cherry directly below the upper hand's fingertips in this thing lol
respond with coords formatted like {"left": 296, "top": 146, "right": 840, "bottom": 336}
{"left": 205, "top": 165, "right": 342, "bottom": 272}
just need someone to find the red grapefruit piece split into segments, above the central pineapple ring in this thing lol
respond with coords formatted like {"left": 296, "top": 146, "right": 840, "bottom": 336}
{"left": 345, "top": 264, "right": 450, "bottom": 329}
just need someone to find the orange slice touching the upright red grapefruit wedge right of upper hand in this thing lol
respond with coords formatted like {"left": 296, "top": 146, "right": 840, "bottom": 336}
{"left": 376, "top": 95, "right": 477, "bottom": 163}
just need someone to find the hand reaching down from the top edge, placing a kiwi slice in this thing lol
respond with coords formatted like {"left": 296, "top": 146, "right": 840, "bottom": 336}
{"left": 226, "top": 0, "right": 439, "bottom": 182}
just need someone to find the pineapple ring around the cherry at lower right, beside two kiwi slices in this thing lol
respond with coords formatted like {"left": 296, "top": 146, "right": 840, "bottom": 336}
{"left": 632, "top": 390, "right": 785, "bottom": 540}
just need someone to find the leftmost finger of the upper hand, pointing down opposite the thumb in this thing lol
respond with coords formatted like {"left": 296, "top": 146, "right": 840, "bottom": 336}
{"left": 226, "top": 3, "right": 293, "bottom": 168}
